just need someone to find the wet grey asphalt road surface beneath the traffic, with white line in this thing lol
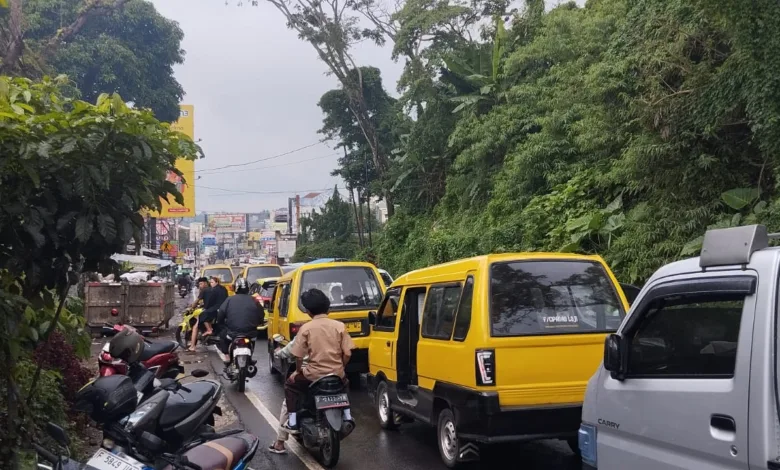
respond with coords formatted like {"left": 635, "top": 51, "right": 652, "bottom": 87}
{"left": 212, "top": 339, "right": 581, "bottom": 470}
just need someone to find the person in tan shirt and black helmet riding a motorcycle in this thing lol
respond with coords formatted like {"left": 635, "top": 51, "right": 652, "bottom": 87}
{"left": 284, "top": 289, "right": 355, "bottom": 434}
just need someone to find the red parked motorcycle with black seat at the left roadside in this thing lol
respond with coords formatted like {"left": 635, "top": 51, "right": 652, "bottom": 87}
{"left": 98, "top": 325, "right": 184, "bottom": 379}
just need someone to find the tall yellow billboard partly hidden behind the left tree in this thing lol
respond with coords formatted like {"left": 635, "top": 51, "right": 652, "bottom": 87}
{"left": 150, "top": 104, "right": 195, "bottom": 219}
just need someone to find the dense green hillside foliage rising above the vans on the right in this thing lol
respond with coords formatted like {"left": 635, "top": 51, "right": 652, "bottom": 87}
{"left": 290, "top": 0, "right": 780, "bottom": 282}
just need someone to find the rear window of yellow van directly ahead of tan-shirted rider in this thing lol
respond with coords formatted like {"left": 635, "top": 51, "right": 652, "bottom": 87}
{"left": 301, "top": 267, "right": 382, "bottom": 311}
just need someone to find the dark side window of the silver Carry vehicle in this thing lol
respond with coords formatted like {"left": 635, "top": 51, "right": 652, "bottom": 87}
{"left": 626, "top": 294, "right": 745, "bottom": 378}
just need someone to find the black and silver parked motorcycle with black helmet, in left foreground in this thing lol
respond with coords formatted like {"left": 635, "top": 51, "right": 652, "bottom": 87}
{"left": 75, "top": 363, "right": 222, "bottom": 462}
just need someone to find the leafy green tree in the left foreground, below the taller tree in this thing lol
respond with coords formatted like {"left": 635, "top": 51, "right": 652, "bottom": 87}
{"left": 0, "top": 77, "right": 200, "bottom": 468}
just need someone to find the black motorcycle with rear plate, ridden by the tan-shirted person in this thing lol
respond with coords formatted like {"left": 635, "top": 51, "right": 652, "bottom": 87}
{"left": 296, "top": 374, "right": 355, "bottom": 468}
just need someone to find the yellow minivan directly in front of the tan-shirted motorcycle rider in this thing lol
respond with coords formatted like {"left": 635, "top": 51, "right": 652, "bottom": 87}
{"left": 268, "top": 261, "right": 385, "bottom": 385}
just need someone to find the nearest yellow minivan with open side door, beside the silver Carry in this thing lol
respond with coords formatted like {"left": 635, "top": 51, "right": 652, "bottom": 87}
{"left": 369, "top": 253, "right": 628, "bottom": 468}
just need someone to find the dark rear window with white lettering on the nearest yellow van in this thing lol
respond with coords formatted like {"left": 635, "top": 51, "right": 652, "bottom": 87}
{"left": 490, "top": 261, "right": 625, "bottom": 336}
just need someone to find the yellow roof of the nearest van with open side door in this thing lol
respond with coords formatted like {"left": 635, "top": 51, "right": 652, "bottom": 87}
{"left": 393, "top": 252, "right": 604, "bottom": 286}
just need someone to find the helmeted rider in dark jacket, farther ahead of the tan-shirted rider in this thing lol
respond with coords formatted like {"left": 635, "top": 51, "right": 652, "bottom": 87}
{"left": 217, "top": 277, "right": 265, "bottom": 366}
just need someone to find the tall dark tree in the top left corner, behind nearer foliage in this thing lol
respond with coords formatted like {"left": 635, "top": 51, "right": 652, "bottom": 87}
{"left": 0, "top": 0, "right": 184, "bottom": 122}
